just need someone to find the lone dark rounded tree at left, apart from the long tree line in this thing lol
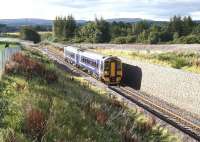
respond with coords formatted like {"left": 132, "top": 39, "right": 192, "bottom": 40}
{"left": 20, "top": 27, "right": 41, "bottom": 43}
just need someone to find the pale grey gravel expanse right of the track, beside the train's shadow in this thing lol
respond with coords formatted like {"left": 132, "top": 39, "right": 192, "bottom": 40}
{"left": 122, "top": 58, "right": 200, "bottom": 115}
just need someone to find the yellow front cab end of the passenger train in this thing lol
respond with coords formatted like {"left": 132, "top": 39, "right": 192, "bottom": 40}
{"left": 103, "top": 57, "right": 122, "bottom": 85}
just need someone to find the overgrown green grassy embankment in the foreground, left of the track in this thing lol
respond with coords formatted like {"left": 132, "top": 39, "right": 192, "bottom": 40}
{"left": 0, "top": 48, "right": 180, "bottom": 142}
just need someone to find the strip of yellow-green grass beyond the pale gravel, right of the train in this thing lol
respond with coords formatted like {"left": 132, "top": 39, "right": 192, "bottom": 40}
{"left": 93, "top": 49, "right": 200, "bottom": 73}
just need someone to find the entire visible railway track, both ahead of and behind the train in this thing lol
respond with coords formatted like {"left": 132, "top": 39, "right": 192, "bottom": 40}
{"left": 29, "top": 45, "right": 200, "bottom": 141}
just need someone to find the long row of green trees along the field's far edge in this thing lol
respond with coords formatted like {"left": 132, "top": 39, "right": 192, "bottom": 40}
{"left": 53, "top": 15, "right": 200, "bottom": 44}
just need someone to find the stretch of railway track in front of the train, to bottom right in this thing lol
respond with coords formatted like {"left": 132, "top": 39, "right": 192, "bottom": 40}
{"left": 109, "top": 86, "right": 200, "bottom": 141}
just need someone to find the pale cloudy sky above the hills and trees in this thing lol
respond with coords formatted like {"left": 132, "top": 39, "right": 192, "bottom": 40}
{"left": 0, "top": 0, "right": 200, "bottom": 20}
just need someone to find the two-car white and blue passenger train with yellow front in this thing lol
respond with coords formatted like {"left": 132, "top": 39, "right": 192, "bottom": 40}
{"left": 64, "top": 46, "right": 122, "bottom": 85}
